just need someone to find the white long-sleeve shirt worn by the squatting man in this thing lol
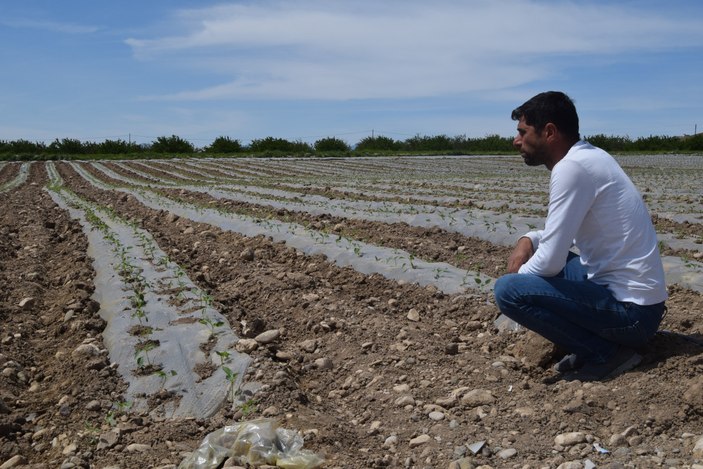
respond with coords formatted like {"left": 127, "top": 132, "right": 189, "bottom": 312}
{"left": 519, "top": 141, "right": 667, "bottom": 305}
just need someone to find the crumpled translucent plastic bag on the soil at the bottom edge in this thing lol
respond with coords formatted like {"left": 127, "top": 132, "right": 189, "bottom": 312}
{"left": 178, "top": 419, "right": 324, "bottom": 469}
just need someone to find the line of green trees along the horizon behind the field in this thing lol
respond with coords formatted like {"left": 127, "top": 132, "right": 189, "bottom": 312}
{"left": 0, "top": 134, "right": 703, "bottom": 160}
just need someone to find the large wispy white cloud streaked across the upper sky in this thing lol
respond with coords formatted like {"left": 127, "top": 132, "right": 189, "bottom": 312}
{"left": 126, "top": 0, "right": 703, "bottom": 100}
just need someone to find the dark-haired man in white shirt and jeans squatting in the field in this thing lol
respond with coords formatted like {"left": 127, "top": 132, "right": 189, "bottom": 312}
{"left": 494, "top": 91, "right": 667, "bottom": 381}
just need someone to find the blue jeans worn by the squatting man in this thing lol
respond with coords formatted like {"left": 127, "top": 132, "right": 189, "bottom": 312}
{"left": 494, "top": 253, "right": 665, "bottom": 363}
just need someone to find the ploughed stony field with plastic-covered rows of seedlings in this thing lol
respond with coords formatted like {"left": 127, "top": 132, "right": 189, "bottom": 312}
{"left": 0, "top": 155, "right": 703, "bottom": 469}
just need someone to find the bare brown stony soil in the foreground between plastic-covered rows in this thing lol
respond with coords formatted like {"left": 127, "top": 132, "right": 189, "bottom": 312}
{"left": 0, "top": 162, "right": 703, "bottom": 469}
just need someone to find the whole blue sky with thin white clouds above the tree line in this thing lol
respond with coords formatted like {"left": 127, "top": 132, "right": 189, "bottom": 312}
{"left": 0, "top": 0, "right": 703, "bottom": 147}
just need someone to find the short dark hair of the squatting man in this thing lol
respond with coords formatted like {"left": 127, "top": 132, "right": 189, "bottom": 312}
{"left": 511, "top": 91, "right": 580, "bottom": 140}
